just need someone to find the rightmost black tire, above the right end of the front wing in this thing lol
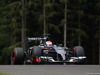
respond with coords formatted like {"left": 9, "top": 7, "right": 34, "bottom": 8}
{"left": 73, "top": 46, "right": 85, "bottom": 57}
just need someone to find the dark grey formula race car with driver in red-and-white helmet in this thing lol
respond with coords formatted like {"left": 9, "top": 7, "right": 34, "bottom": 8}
{"left": 11, "top": 37, "right": 86, "bottom": 64}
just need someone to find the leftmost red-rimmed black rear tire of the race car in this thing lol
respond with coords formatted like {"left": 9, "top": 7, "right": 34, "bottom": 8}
{"left": 11, "top": 47, "right": 24, "bottom": 65}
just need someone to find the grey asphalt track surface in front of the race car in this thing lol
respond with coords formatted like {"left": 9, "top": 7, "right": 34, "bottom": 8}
{"left": 0, "top": 65, "right": 100, "bottom": 75}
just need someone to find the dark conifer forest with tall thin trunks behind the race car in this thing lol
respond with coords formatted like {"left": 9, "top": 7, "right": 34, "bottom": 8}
{"left": 0, "top": 0, "right": 100, "bottom": 64}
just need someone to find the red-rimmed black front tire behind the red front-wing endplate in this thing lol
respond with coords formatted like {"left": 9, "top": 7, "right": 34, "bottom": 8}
{"left": 31, "top": 46, "right": 42, "bottom": 64}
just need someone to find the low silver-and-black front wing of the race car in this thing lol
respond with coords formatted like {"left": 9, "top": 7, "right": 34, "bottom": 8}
{"left": 38, "top": 56, "right": 86, "bottom": 63}
